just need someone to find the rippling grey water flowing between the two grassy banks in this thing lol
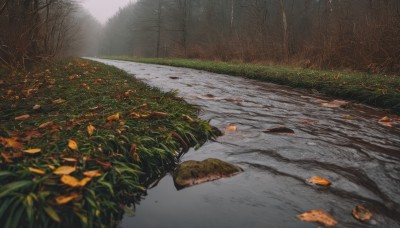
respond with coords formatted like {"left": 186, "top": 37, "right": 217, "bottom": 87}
{"left": 88, "top": 60, "right": 400, "bottom": 227}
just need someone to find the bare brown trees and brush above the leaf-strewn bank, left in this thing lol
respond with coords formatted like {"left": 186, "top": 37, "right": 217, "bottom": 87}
{"left": 0, "top": 0, "right": 101, "bottom": 68}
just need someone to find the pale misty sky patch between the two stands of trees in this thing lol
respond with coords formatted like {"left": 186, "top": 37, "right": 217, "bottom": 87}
{"left": 80, "top": 0, "right": 133, "bottom": 24}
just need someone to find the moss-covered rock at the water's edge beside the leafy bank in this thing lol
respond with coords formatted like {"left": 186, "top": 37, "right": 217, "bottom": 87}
{"left": 174, "top": 158, "right": 242, "bottom": 190}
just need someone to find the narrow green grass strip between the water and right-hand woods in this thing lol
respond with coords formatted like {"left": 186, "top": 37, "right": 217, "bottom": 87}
{"left": 105, "top": 56, "right": 400, "bottom": 114}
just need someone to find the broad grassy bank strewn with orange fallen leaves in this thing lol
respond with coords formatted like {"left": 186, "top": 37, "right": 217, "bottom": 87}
{"left": 0, "top": 60, "right": 214, "bottom": 227}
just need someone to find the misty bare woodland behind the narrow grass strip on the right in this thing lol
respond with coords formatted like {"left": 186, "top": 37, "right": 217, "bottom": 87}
{"left": 99, "top": 0, "right": 400, "bottom": 73}
